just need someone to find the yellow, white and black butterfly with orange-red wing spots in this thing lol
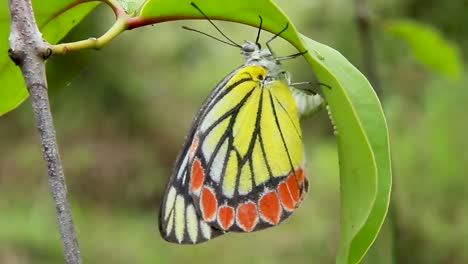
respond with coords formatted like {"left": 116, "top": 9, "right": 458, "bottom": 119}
{"left": 159, "top": 3, "right": 323, "bottom": 244}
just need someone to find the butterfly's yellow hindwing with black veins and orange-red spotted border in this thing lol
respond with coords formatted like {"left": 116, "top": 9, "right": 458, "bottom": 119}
{"left": 189, "top": 65, "right": 308, "bottom": 232}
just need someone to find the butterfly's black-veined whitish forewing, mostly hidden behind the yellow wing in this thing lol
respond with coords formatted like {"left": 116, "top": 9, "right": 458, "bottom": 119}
{"left": 159, "top": 66, "right": 243, "bottom": 244}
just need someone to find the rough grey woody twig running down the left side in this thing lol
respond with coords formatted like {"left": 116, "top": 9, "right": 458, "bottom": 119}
{"left": 8, "top": 0, "right": 81, "bottom": 264}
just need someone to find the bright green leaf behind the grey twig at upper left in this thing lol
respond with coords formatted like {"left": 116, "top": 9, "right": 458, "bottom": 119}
{"left": 0, "top": 0, "right": 98, "bottom": 116}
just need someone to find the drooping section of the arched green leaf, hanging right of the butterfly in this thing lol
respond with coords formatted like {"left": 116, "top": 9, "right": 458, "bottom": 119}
{"left": 303, "top": 37, "right": 392, "bottom": 263}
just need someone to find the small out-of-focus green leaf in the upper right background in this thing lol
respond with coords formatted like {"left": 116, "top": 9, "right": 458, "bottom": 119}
{"left": 385, "top": 19, "right": 463, "bottom": 80}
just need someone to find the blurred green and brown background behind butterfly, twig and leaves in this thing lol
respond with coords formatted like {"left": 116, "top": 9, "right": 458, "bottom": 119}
{"left": 0, "top": 0, "right": 468, "bottom": 264}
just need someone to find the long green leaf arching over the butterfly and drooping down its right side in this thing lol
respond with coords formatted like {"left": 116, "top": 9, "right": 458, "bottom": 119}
{"left": 141, "top": 0, "right": 391, "bottom": 263}
